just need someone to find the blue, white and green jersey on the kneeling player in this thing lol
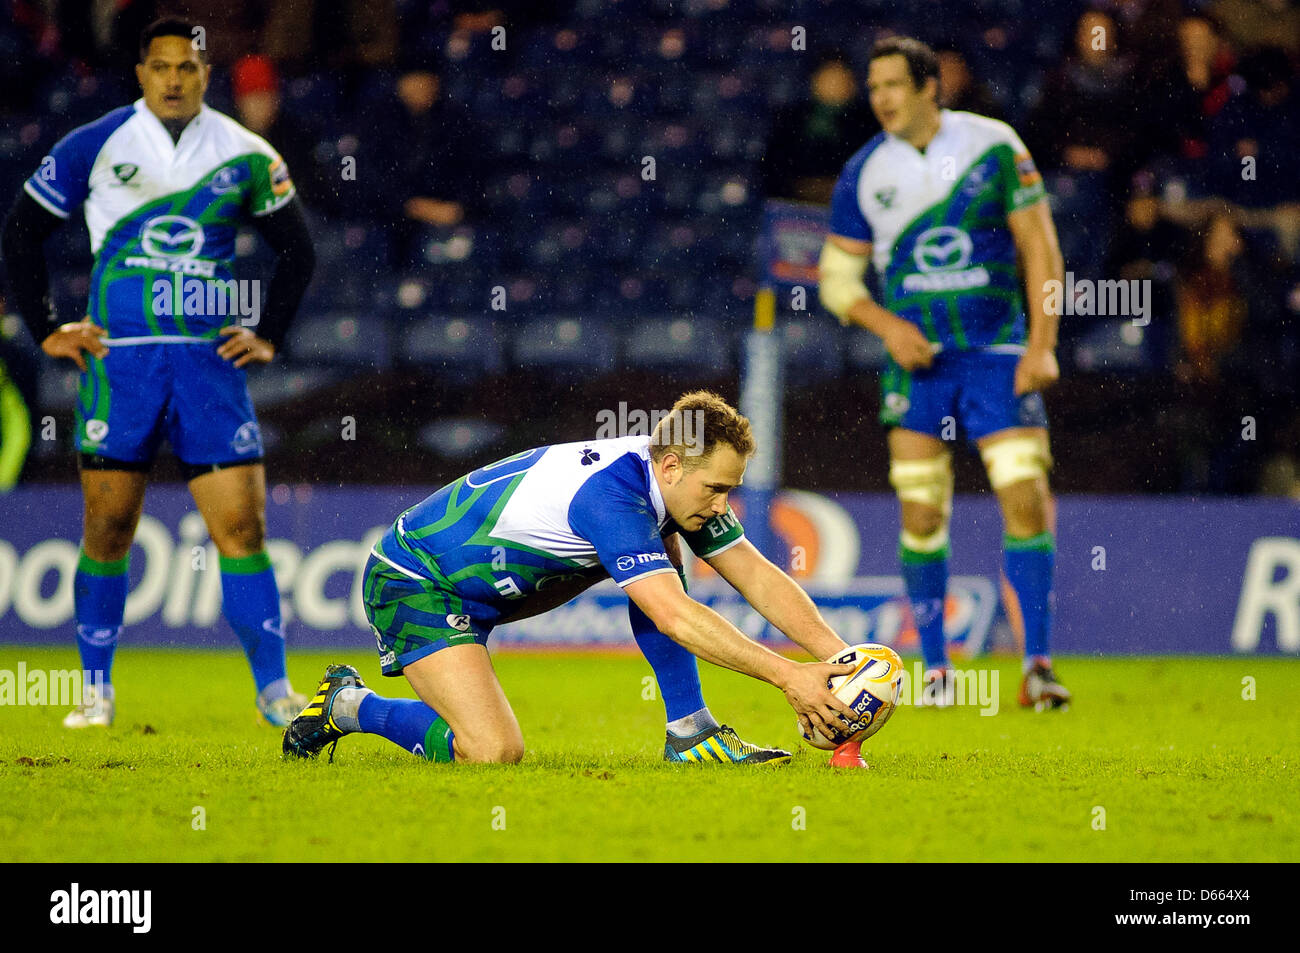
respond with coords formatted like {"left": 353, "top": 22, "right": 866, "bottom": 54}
{"left": 374, "top": 436, "right": 745, "bottom": 623}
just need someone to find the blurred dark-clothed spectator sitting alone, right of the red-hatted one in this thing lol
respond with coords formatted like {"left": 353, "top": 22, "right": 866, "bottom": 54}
{"left": 363, "top": 64, "right": 494, "bottom": 261}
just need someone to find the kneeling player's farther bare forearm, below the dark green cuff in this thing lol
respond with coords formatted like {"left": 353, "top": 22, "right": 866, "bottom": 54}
{"left": 706, "top": 540, "right": 849, "bottom": 659}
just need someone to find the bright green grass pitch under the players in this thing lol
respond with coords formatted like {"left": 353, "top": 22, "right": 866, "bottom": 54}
{"left": 0, "top": 646, "right": 1300, "bottom": 861}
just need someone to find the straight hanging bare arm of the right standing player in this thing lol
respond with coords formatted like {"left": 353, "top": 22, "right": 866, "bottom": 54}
{"left": 1006, "top": 200, "right": 1065, "bottom": 397}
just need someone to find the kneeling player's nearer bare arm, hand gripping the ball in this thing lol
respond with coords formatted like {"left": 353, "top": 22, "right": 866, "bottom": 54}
{"left": 624, "top": 572, "right": 854, "bottom": 725}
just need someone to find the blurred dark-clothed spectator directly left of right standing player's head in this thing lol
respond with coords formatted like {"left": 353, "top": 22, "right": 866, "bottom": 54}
{"left": 763, "top": 53, "right": 880, "bottom": 205}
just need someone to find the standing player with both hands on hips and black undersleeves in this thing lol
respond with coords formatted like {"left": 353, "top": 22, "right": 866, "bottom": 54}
{"left": 3, "top": 18, "right": 315, "bottom": 728}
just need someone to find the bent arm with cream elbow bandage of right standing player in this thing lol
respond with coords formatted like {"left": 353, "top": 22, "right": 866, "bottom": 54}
{"left": 818, "top": 235, "right": 935, "bottom": 371}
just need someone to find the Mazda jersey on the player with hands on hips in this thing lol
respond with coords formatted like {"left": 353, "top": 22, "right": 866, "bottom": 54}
{"left": 23, "top": 99, "right": 294, "bottom": 343}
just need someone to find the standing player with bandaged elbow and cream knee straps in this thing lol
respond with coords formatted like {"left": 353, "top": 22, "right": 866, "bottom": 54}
{"left": 820, "top": 38, "right": 1070, "bottom": 707}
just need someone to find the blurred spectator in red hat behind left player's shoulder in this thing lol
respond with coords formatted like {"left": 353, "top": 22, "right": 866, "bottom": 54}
{"left": 230, "top": 56, "right": 338, "bottom": 213}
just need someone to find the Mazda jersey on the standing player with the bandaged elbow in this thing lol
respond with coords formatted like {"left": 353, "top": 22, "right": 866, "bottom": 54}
{"left": 831, "top": 109, "right": 1047, "bottom": 350}
